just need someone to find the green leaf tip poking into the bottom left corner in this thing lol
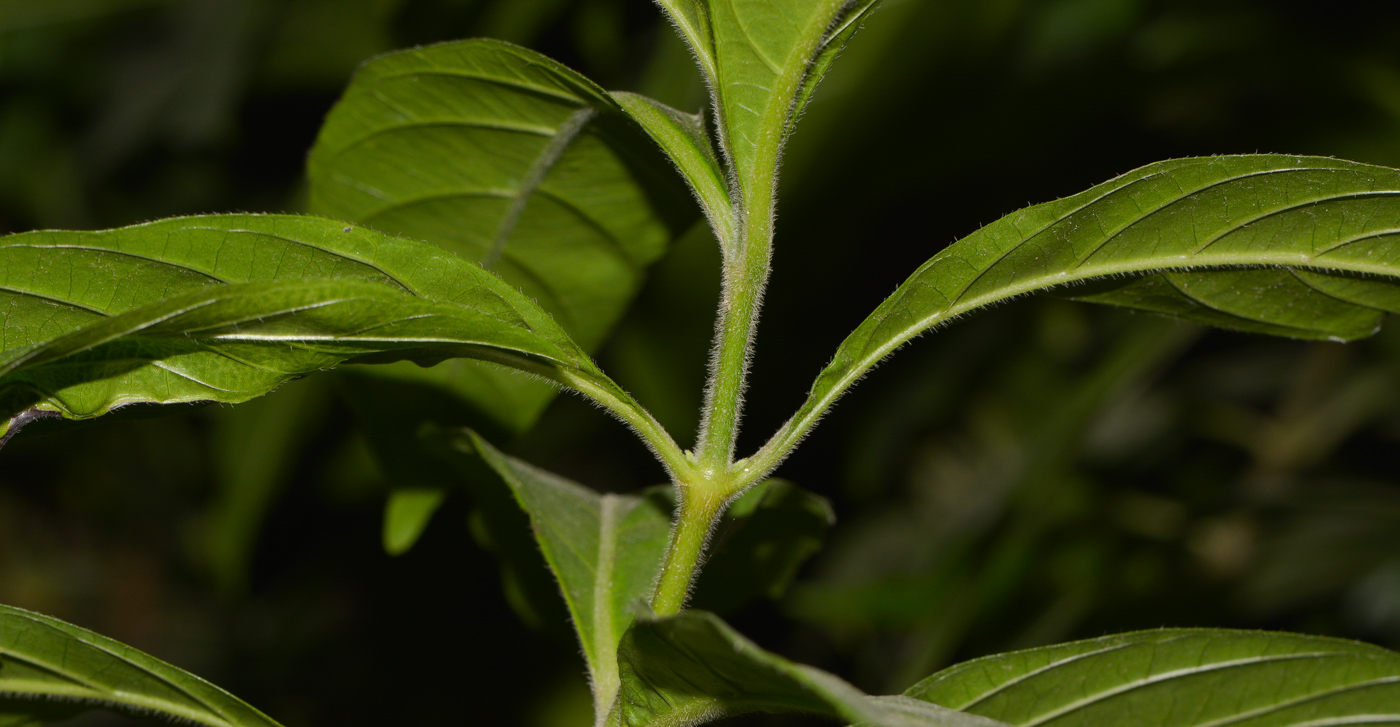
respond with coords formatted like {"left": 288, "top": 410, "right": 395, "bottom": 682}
{"left": 0, "top": 605, "right": 277, "bottom": 727}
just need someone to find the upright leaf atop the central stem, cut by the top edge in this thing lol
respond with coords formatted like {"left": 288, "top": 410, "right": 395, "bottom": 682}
{"left": 661, "top": 0, "right": 875, "bottom": 193}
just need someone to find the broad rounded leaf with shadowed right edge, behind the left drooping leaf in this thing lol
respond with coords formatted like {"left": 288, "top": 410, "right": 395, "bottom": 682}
{"left": 308, "top": 39, "right": 706, "bottom": 448}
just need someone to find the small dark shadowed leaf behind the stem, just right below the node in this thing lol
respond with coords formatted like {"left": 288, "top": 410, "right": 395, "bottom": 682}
{"left": 694, "top": 479, "right": 836, "bottom": 614}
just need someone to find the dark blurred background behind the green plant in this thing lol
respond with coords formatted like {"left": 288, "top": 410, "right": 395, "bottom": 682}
{"left": 0, "top": 0, "right": 1400, "bottom": 727}
